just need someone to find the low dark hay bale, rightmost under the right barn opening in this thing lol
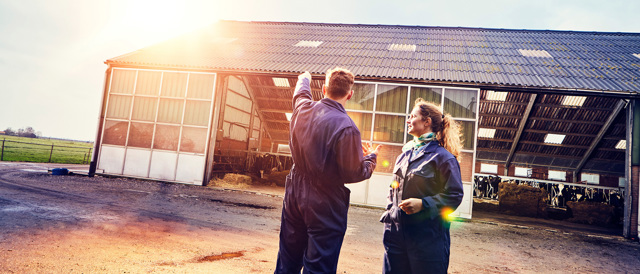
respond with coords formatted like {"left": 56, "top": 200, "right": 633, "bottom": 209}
{"left": 567, "top": 201, "right": 615, "bottom": 226}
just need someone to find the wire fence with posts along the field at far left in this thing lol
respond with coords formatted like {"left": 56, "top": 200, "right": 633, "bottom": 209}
{"left": 0, "top": 139, "right": 93, "bottom": 164}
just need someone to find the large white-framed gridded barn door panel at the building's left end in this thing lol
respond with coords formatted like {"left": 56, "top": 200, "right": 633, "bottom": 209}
{"left": 99, "top": 68, "right": 215, "bottom": 186}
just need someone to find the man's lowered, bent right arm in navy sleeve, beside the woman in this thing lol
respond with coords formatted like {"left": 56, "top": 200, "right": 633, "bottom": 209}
{"left": 335, "top": 127, "right": 377, "bottom": 183}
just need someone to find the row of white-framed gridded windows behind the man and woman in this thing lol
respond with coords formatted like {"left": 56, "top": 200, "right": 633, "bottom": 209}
{"left": 345, "top": 82, "right": 478, "bottom": 176}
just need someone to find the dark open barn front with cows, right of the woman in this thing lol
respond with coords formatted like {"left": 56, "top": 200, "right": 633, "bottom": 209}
{"left": 473, "top": 90, "right": 632, "bottom": 231}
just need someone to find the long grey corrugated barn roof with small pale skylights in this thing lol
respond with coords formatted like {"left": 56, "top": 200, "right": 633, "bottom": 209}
{"left": 107, "top": 21, "right": 640, "bottom": 95}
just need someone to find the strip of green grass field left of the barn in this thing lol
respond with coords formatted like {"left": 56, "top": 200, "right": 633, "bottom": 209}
{"left": 0, "top": 135, "right": 93, "bottom": 164}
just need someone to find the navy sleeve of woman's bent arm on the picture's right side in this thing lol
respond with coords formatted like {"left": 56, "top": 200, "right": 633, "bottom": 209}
{"left": 422, "top": 158, "right": 464, "bottom": 219}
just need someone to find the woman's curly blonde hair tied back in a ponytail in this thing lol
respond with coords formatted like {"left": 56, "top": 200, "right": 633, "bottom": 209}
{"left": 413, "top": 98, "right": 462, "bottom": 158}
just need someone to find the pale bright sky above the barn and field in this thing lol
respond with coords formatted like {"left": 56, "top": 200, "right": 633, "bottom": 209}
{"left": 0, "top": 0, "right": 640, "bottom": 141}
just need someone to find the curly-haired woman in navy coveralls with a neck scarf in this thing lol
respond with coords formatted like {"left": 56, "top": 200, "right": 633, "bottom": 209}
{"left": 380, "top": 98, "right": 463, "bottom": 273}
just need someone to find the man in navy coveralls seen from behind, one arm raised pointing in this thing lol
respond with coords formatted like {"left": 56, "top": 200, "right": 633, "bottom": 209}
{"left": 275, "top": 68, "right": 380, "bottom": 273}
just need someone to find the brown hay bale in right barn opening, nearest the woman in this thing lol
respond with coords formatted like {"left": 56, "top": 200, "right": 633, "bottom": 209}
{"left": 498, "top": 182, "right": 548, "bottom": 218}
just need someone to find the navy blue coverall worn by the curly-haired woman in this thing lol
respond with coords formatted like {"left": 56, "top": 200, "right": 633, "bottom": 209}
{"left": 380, "top": 141, "right": 464, "bottom": 273}
